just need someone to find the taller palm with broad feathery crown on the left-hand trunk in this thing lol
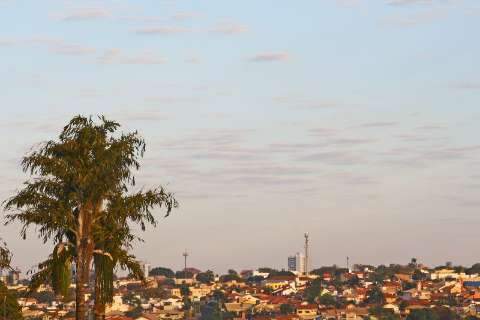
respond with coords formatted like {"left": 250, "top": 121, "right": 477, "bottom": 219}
{"left": 5, "top": 116, "right": 178, "bottom": 320}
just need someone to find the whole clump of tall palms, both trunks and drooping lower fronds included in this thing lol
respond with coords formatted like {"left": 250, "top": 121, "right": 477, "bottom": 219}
{"left": 5, "top": 116, "right": 178, "bottom": 319}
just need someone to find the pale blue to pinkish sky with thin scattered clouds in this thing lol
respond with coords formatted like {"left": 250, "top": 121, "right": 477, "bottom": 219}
{"left": 0, "top": 0, "right": 480, "bottom": 272}
